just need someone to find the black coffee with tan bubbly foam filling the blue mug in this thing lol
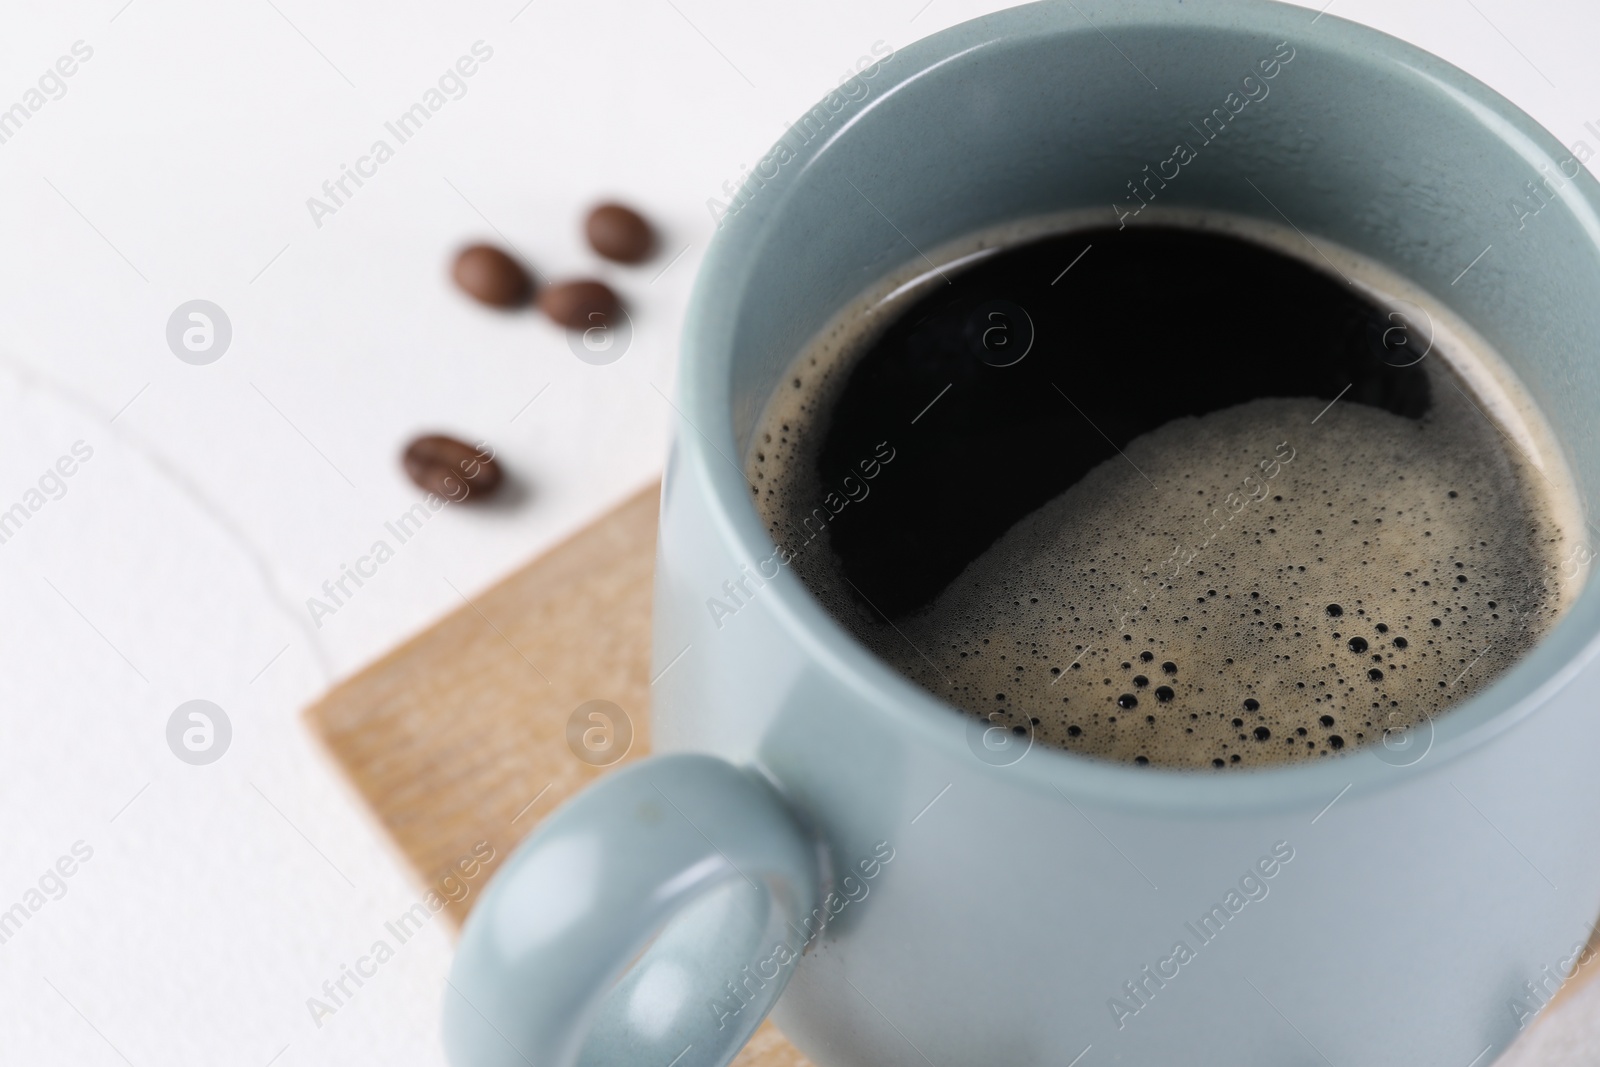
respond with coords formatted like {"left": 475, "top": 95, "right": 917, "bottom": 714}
{"left": 749, "top": 220, "right": 1576, "bottom": 768}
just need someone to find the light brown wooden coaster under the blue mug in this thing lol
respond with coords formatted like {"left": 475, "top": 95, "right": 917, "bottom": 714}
{"left": 306, "top": 485, "right": 1600, "bottom": 1067}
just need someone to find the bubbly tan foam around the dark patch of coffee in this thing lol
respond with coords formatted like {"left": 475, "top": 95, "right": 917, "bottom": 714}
{"left": 747, "top": 216, "right": 1581, "bottom": 768}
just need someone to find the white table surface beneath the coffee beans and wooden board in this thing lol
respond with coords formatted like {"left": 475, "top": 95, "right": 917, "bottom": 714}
{"left": 0, "top": 0, "right": 1600, "bottom": 1067}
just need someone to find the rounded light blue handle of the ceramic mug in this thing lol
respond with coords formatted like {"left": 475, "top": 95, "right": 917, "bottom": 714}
{"left": 443, "top": 753, "right": 826, "bottom": 1067}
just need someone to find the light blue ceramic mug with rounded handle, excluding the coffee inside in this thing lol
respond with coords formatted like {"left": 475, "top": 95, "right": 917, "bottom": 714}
{"left": 445, "top": 0, "right": 1600, "bottom": 1067}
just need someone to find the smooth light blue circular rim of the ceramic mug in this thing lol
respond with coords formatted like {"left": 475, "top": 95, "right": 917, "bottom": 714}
{"left": 677, "top": 0, "right": 1600, "bottom": 816}
